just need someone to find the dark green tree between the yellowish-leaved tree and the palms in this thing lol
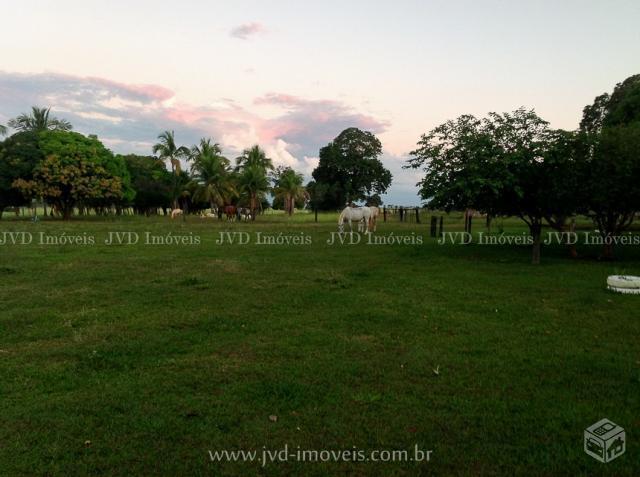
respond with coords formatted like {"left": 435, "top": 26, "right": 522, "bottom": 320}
{"left": 122, "top": 154, "right": 173, "bottom": 215}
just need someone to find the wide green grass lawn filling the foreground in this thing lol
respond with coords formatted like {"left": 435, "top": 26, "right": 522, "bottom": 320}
{"left": 0, "top": 215, "right": 640, "bottom": 476}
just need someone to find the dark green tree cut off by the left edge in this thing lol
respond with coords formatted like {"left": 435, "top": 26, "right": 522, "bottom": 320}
{"left": 0, "top": 132, "right": 44, "bottom": 218}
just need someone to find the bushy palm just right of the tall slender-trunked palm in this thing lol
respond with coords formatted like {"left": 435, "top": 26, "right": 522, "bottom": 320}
{"left": 191, "top": 139, "right": 237, "bottom": 212}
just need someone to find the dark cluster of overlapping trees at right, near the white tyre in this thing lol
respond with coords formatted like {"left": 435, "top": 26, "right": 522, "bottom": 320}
{"left": 405, "top": 75, "right": 640, "bottom": 263}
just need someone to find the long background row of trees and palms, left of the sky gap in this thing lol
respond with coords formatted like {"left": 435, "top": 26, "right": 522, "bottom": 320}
{"left": 0, "top": 107, "right": 391, "bottom": 220}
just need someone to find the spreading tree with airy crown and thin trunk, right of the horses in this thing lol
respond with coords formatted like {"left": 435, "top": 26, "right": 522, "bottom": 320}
{"left": 408, "top": 108, "right": 554, "bottom": 264}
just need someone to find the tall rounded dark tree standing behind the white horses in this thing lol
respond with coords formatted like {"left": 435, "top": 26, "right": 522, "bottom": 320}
{"left": 312, "top": 128, "right": 392, "bottom": 209}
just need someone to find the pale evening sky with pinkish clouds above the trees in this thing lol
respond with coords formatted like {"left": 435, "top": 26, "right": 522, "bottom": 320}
{"left": 0, "top": 0, "right": 640, "bottom": 205}
